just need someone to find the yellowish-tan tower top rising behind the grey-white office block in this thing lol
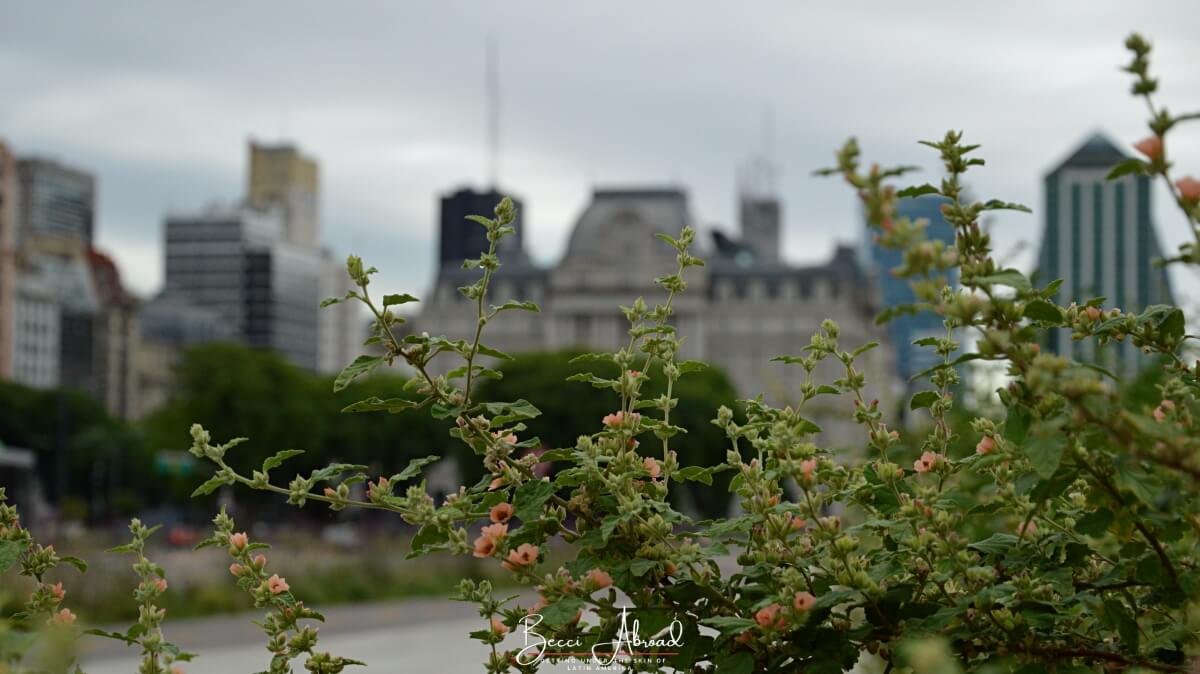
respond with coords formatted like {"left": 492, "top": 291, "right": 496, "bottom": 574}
{"left": 246, "top": 140, "right": 320, "bottom": 247}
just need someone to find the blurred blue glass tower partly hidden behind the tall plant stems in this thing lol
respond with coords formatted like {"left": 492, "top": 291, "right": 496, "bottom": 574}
{"left": 863, "top": 194, "right": 958, "bottom": 389}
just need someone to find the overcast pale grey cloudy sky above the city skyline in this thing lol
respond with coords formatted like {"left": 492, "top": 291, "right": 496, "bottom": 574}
{"left": 0, "top": 0, "right": 1200, "bottom": 297}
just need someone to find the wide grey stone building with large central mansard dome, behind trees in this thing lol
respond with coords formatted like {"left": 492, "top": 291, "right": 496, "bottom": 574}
{"left": 414, "top": 182, "right": 895, "bottom": 441}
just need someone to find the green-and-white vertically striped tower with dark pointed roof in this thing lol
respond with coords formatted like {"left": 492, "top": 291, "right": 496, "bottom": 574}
{"left": 1036, "top": 133, "right": 1175, "bottom": 372}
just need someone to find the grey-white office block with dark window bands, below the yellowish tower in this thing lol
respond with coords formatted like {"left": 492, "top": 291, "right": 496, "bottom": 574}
{"left": 164, "top": 206, "right": 326, "bottom": 371}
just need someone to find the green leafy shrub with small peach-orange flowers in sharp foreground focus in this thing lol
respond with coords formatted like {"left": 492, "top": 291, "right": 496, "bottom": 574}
{"left": 2, "top": 31, "right": 1200, "bottom": 674}
